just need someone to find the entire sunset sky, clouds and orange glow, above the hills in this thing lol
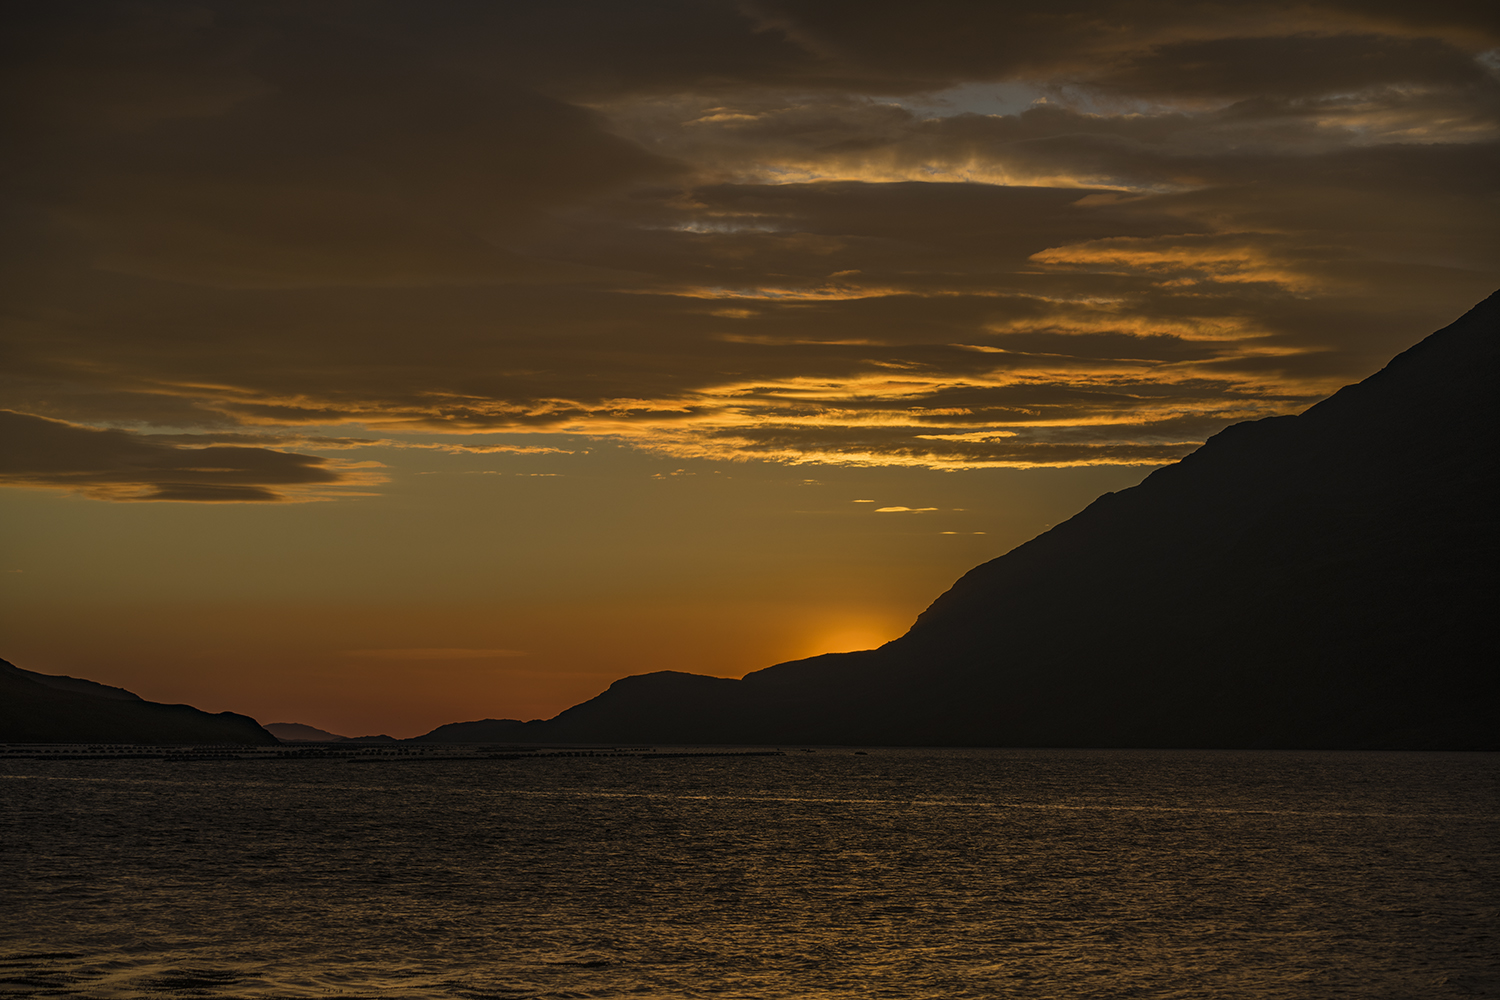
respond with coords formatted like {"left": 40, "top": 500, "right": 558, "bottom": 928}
{"left": 0, "top": 0, "right": 1500, "bottom": 736}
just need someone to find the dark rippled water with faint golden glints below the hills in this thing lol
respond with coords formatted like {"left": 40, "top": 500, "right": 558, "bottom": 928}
{"left": 0, "top": 750, "right": 1500, "bottom": 999}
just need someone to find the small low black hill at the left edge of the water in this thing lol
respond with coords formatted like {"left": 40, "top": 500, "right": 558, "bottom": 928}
{"left": 0, "top": 660, "right": 278, "bottom": 744}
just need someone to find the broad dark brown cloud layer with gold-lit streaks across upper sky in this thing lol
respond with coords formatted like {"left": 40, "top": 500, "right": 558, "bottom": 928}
{"left": 3, "top": 0, "right": 1500, "bottom": 499}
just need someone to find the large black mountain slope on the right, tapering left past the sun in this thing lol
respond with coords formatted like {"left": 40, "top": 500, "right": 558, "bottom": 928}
{"left": 420, "top": 284, "right": 1500, "bottom": 748}
